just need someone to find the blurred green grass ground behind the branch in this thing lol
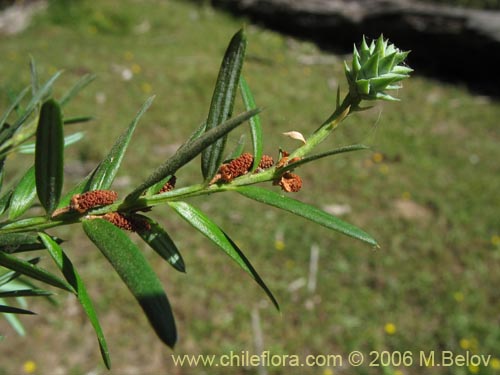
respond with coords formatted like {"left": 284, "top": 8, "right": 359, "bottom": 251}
{"left": 0, "top": 0, "right": 500, "bottom": 374}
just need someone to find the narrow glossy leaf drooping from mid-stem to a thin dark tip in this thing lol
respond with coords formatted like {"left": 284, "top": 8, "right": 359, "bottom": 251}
{"left": 168, "top": 202, "right": 279, "bottom": 310}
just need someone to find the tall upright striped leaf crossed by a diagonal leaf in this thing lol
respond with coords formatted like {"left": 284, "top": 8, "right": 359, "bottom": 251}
{"left": 201, "top": 30, "right": 246, "bottom": 180}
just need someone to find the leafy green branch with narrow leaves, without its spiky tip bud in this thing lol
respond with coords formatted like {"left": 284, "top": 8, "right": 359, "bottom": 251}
{"left": 0, "top": 30, "right": 410, "bottom": 368}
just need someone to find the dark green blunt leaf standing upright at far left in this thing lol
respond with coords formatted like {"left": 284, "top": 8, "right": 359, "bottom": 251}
{"left": 35, "top": 99, "right": 64, "bottom": 214}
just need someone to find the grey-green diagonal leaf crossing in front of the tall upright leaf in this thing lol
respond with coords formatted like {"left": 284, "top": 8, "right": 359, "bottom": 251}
{"left": 125, "top": 109, "right": 260, "bottom": 201}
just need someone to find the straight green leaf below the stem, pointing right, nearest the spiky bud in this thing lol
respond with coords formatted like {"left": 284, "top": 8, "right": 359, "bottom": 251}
{"left": 237, "top": 186, "right": 378, "bottom": 247}
